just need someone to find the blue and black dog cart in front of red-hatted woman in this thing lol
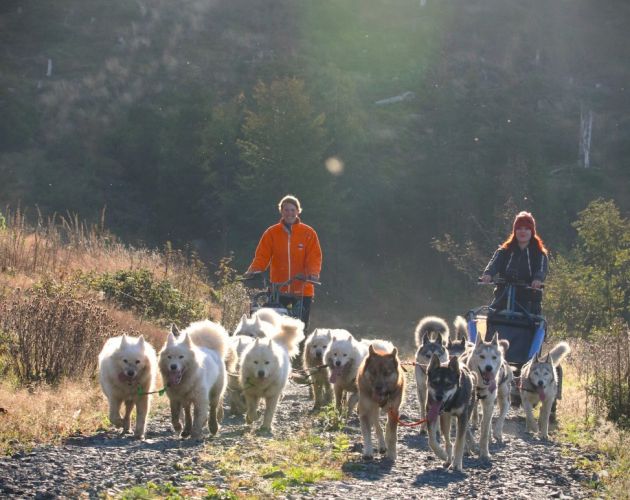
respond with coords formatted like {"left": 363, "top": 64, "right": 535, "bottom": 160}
{"left": 466, "top": 279, "right": 562, "bottom": 407}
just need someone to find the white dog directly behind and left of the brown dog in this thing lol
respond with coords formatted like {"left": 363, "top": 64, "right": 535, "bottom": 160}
{"left": 324, "top": 329, "right": 369, "bottom": 415}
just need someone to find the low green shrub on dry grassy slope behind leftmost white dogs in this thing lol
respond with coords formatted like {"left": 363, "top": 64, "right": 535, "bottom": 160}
{"left": 88, "top": 269, "right": 205, "bottom": 325}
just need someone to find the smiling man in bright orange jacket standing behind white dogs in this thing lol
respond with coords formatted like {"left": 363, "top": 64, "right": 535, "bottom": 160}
{"left": 246, "top": 195, "right": 322, "bottom": 340}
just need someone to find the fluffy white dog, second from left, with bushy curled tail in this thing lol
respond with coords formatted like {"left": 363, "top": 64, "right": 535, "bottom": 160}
{"left": 159, "top": 320, "right": 229, "bottom": 439}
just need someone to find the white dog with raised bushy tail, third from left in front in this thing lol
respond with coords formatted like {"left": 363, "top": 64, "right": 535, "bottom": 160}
{"left": 240, "top": 318, "right": 304, "bottom": 432}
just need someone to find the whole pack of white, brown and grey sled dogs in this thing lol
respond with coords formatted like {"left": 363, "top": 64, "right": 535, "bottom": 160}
{"left": 99, "top": 309, "right": 570, "bottom": 471}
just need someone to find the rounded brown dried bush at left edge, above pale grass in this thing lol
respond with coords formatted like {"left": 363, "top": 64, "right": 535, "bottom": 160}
{"left": 0, "top": 282, "right": 122, "bottom": 384}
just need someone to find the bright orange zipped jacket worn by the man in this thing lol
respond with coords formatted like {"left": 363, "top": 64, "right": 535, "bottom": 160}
{"left": 249, "top": 218, "right": 322, "bottom": 297}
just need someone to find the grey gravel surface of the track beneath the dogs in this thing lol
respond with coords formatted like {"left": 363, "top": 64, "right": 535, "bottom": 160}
{"left": 0, "top": 376, "right": 589, "bottom": 499}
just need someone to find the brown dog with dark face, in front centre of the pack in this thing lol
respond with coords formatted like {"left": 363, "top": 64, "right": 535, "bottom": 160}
{"left": 357, "top": 341, "right": 405, "bottom": 460}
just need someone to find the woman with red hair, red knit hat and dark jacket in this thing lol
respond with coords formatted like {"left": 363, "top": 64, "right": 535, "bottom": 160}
{"left": 481, "top": 212, "right": 549, "bottom": 314}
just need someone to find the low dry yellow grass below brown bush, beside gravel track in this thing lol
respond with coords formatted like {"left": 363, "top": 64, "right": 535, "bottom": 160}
{"left": 0, "top": 380, "right": 108, "bottom": 455}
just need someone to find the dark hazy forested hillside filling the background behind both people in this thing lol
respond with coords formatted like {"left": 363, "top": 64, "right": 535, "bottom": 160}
{"left": 0, "top": 0, "right": 630, "bottom": 332}
